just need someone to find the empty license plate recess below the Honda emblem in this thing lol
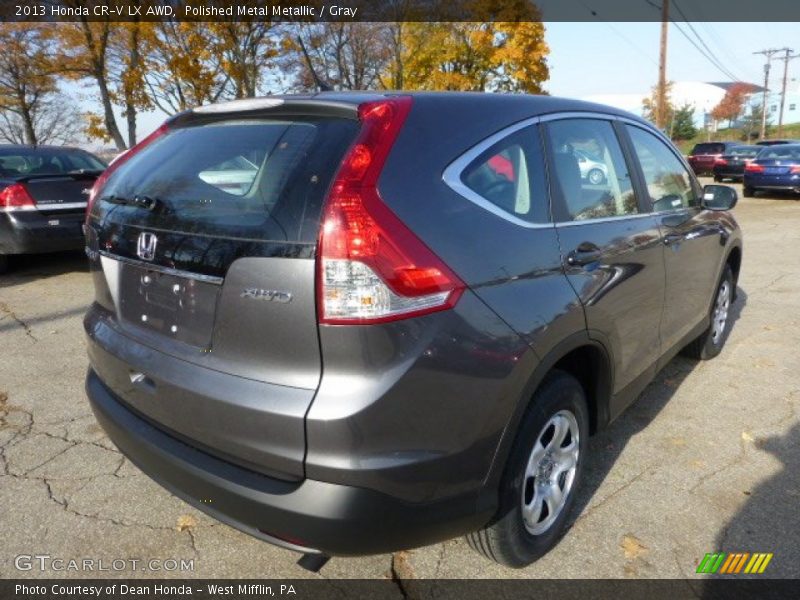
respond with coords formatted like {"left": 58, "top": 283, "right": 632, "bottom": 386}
{"left": 119, "top": 263, "right": 221, "bottom": 348}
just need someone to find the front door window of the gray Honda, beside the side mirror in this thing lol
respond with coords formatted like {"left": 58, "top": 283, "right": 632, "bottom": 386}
{"left": 626, "top": 125, "right": 699, "bottom": 212}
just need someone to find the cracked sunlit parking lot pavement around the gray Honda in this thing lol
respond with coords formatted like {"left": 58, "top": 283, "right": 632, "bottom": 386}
{"left": 0, "top": 179, "right": 800, "bottom": 579}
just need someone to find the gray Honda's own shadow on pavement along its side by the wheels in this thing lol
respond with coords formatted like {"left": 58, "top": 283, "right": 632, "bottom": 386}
{"left": 570, "top": 287, "right": 747, "bottom": 526}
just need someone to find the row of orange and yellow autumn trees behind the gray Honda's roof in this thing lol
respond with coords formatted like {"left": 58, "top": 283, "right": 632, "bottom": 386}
{"left": 0, "top": 14, "right": 549, "bottom": 150}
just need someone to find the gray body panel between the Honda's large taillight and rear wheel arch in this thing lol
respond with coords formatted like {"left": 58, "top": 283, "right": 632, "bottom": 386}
{"left": 306, "top": 292, "right": 536, "bottom": 501}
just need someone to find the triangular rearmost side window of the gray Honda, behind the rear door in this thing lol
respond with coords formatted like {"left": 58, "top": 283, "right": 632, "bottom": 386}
{"left": 461, "top": 125, "right": 548, "bottom": 223}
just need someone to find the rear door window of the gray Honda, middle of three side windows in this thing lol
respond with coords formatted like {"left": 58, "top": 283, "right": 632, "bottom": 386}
{"left": 547, "top": 119, "right": 639, "bottom": 222}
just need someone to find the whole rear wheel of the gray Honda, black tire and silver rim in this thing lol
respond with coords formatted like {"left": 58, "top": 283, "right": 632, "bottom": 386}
{"left": 467, "top": 371, "right": 589, "bottom": 568}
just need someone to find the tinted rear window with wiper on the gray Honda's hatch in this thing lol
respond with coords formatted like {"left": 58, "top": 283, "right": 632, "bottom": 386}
{"left": 96, "top": 118, "right": 358, "bottom": 242}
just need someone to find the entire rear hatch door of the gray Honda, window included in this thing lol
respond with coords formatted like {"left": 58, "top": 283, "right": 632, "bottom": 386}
{"left": 87, "top": 107, "right": 358, "bottom": 479}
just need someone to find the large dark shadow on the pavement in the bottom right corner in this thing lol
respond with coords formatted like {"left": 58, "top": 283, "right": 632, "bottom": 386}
{"left": 702, "top": 422, "right": 800, "bottom": 599}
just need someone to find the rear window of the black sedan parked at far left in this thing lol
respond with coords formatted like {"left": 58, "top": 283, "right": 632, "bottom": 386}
{"left": 0, "top": 148, "right": 106, "bottom": 179}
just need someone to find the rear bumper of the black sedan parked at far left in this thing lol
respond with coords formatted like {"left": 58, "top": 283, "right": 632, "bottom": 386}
{"left": 0, "top": 211, "right": 85, "bottom": 254}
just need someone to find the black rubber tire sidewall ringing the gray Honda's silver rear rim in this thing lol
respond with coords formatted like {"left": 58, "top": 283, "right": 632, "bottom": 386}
{"left": 500, "top": 373, "right": 589, "bottom": 566}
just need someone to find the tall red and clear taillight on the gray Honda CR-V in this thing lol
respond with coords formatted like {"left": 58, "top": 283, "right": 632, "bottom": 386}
{"left": 317, "top": 96, "right": 464, "bottom": 325}
